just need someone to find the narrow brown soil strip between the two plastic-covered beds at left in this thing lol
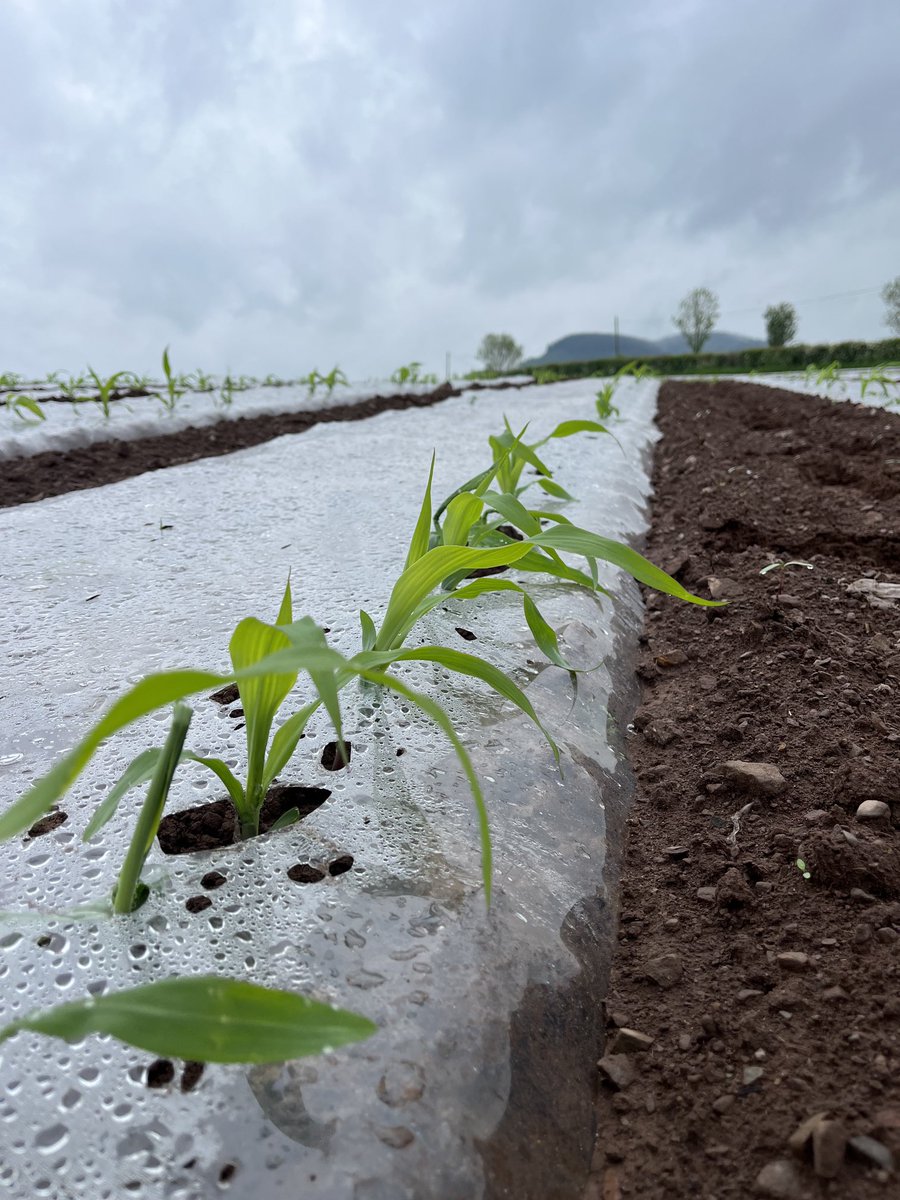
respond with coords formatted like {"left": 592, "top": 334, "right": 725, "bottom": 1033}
{"left": 0, "top": 383, "right": 529, "bottom": 508}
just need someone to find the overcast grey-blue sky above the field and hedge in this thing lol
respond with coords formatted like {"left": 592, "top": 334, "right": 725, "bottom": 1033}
{"left": 0, "top": 0, "right": 900, "bottom": 378}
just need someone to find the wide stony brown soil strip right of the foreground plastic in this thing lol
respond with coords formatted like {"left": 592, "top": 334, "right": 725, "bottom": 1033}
{"left": 587, "top": 383, "right": 900, "bottom": 1200}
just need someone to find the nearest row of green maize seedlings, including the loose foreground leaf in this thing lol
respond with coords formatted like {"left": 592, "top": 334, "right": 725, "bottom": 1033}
{"left": 0, "top": 389, "right": 713, "bottom": 1062}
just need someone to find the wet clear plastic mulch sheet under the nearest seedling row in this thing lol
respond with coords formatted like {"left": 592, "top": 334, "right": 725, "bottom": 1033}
{"left": 0, "top": 380, "right": 655, "bottom": 1200}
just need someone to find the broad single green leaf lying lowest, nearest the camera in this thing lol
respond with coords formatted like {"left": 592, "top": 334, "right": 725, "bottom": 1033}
{"left": 0, "top": 976, "right": 376, "bottom": 1063}
